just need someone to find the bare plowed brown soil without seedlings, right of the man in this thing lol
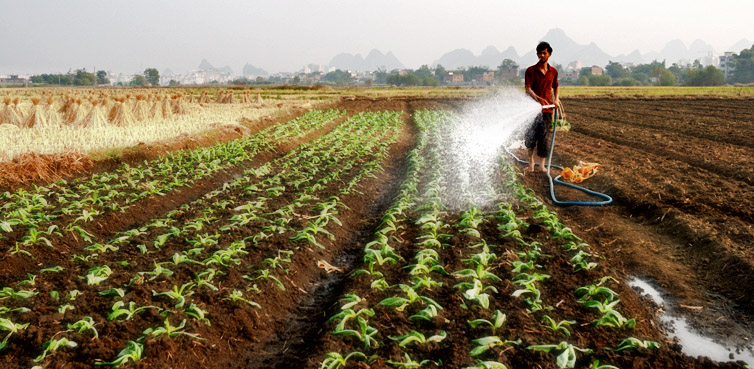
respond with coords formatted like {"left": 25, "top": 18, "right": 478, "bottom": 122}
{"left": 527, "top": 98, "right": 754, "bottom": 360}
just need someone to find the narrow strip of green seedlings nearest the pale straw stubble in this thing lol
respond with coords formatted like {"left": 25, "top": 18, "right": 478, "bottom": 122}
{"left": 0, "top": 110, "right": 345, "bottom": 255}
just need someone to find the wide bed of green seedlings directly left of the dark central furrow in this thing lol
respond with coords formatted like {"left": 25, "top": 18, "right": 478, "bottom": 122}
{"left": 0, "top": 112, "right": 401, "bottom": 365}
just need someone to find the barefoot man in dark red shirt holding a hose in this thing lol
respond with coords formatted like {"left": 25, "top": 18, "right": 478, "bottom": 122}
{"left": 524, "top": 41, "right": 560, "bottom": 172}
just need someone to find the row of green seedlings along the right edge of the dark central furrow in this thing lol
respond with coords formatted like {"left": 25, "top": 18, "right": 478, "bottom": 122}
{"left": 320, "top": 108, "right": 428, "bottom": 369}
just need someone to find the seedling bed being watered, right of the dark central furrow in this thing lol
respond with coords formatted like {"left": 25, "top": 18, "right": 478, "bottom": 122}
{"left": 319, "top": 111, "right": 658, "bottom": 369}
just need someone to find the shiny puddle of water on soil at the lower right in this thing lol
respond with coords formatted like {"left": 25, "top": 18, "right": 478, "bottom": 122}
{"left": 628, "top": 278, "right": 754, "bottom": 365}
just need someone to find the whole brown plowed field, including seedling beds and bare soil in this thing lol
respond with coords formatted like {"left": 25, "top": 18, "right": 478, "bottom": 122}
{"left": 0, "top": 98, "right": 754, "bottom": 369}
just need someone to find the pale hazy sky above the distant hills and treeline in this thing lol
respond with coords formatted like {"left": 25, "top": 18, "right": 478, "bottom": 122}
{"left": 0, "top": 0, "right": 754, "bottom": 74}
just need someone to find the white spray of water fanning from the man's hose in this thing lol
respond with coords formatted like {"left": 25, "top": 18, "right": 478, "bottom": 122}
{"left": 443, "top": 88, "right": 541, "bottom": 210}
